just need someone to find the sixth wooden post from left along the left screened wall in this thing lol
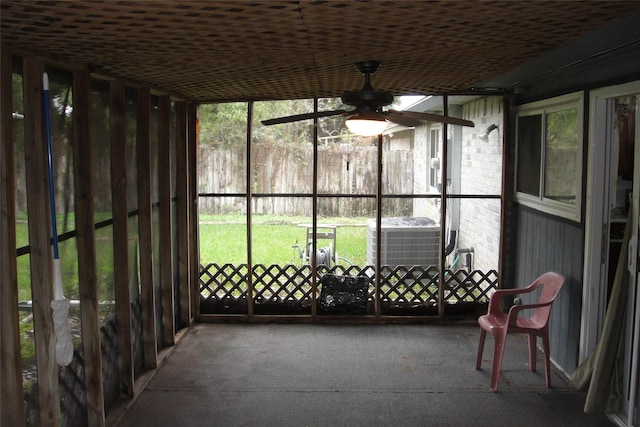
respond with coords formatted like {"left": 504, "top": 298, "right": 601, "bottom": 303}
{"left": 158, "top": 96, "right": 176, "bottom": 346}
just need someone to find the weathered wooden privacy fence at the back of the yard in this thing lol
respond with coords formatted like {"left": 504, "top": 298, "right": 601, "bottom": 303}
{"left": 198, "top": 143, "right": 414, "bottom": 216}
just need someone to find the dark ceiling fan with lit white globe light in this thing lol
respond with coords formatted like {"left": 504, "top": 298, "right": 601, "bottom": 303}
{"left": 262, "top": 60, "right": 474, "bottom": 136}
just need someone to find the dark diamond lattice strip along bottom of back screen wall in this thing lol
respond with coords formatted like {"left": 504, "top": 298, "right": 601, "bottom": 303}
{"left": 200, "top": 263, "right": 498, "bottom": 315}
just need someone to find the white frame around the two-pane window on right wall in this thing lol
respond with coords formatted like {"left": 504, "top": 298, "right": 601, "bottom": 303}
{"left": 514, "top": 92, "right": 585, "bottom": 222}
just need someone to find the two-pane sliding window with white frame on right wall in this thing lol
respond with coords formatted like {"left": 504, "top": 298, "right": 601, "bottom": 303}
{"left": 516, "top": 94, "right": 583, "bottom": 221}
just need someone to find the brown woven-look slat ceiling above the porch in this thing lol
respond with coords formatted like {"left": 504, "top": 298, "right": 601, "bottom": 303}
{"left": 0, "top": 0, "right": 640, "bottom": 102}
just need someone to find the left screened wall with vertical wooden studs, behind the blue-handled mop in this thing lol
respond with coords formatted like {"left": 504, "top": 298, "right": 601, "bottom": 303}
{"left": 1, "top": 55, "right": 194, "bottom": 426}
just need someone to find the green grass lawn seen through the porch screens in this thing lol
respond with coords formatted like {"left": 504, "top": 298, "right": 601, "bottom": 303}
{"left": 16, "top": 213, "right": 368, "bottom": 301}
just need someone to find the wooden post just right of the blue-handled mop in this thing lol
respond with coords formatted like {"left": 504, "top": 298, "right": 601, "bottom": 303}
{"left": 73, "top": 72, "right": 105, "bottom": 426}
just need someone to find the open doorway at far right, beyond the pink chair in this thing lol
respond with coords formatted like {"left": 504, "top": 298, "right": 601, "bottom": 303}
{"left": 580, "top": 82, "right": 640, "bottom": 426}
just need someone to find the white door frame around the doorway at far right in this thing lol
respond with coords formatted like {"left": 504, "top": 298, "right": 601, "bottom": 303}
{"left": 578, "top": 81, "right": 640, "bottom": 426}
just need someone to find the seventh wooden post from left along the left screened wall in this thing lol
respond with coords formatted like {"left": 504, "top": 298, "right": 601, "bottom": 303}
{"left": 176, "top": 101, "right": 191, "bottom": 327}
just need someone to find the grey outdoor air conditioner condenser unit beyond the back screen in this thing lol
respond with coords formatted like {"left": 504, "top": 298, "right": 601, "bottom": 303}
{"left": 367, "top": 217, "right": 440, "bottom": 267}
